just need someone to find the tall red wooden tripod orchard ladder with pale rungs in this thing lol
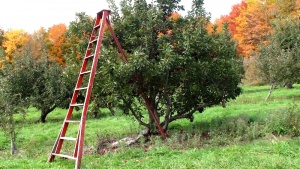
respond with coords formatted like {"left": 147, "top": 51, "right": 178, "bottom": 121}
{"left": 48, "top": 10, "right": 166, "bottom": 169}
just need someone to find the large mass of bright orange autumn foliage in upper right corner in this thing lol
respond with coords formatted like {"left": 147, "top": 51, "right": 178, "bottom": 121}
{"left": 218, "top": 0, "right": 300, "bottom": 57}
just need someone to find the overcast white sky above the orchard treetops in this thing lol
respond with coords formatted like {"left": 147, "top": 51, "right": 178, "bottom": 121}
{"left": 0, "top": 0, "right": 241, "bottom": 33}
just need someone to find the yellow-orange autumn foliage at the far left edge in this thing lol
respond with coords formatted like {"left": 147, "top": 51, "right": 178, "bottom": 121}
{"left": 3, "top": 29, "right": 29, "bottom": 62}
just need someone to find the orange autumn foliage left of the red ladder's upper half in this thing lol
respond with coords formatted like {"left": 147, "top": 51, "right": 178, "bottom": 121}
{"left": 48, "top": 24, "right": 67, "bottom": 65}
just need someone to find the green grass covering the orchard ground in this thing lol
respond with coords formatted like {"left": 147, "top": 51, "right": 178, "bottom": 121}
{"left": 0, "top": 85, "right": 300, "bottom": 169}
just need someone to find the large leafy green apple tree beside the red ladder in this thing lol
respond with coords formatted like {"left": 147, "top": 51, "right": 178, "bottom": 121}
{"left": 94, "top": 0, "right": 243, "bottom": 135}
